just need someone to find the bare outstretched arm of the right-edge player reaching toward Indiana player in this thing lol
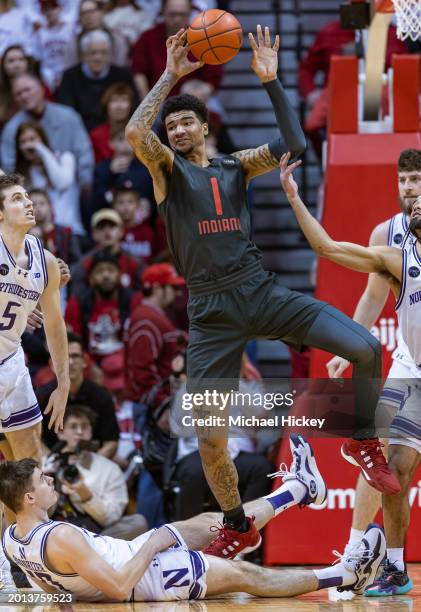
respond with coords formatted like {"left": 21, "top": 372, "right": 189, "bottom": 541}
{"left": 280, "top": 153, "right": 402, "bottom": 281}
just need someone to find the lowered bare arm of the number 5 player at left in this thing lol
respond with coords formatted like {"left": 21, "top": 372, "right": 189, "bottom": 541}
{"left": 39, "top": 251, "right": 70, "bottom": 433}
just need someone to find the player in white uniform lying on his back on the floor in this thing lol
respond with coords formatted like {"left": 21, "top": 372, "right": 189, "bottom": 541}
{"left": 0, "top": 435, "right": 385, "bottom": 602}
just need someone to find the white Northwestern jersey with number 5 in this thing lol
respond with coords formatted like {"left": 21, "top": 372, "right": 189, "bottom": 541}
{"left": 0, "top": 234, "right": 48, "bottom": 360}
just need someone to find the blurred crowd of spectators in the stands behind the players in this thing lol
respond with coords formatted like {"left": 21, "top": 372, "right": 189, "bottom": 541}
{"left": 0, "top": 0, "right": 414, "bottom": 538}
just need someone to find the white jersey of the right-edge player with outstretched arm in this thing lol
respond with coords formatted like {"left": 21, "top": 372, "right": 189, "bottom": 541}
{"left": 395, "top": 242, "right": 421, "bottom": 368}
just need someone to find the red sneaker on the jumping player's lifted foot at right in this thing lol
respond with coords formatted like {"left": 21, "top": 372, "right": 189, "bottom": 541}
{"left": 341, "top": 438, "right": 401, "bottom": 495}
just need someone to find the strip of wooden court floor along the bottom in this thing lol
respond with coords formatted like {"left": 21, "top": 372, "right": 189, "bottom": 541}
{"left": 0, "top": 564, "right": 421, "bottom": 612}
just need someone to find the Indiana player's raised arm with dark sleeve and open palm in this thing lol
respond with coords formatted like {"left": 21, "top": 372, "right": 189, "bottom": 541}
{"left": 233, "top": 25, "right": 306, "bottom": 180}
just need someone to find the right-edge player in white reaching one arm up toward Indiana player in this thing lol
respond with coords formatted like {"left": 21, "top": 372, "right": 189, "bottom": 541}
{"left": 281, "top": 154, "right": 421, "bottom": 596}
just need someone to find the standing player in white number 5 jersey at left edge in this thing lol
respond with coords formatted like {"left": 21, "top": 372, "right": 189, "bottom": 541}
{"left": 0, "top": 175, "right": 70, "bottom": 588}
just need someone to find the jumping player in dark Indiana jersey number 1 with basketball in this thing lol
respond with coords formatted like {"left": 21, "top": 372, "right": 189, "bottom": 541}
{"left": 126, "top": 26, "right": 400, "bottom": 558}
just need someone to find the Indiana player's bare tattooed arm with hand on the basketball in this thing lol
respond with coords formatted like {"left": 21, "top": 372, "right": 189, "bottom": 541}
{"left": 126, "top": 30, "right": 203, "bottom": 203}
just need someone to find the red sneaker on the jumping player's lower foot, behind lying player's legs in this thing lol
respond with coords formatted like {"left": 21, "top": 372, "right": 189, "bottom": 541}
{"left": 202, "top": 516, "right": 262, "bottom": 559}
